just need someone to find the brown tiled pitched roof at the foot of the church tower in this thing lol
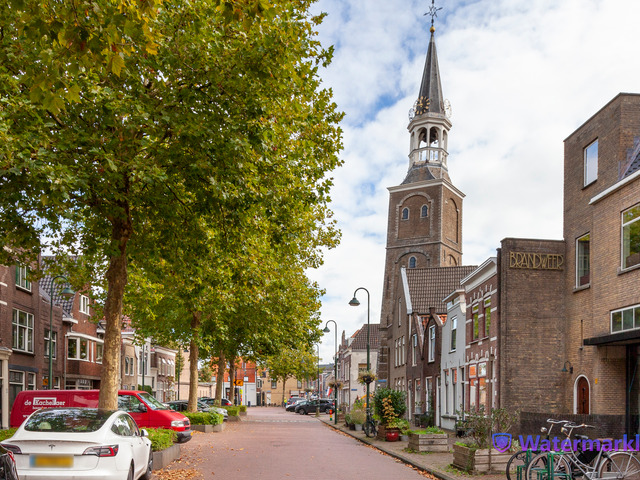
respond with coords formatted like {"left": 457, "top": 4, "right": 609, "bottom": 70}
{"left": 406, "top": 265, "right": 478, "bottom": 313}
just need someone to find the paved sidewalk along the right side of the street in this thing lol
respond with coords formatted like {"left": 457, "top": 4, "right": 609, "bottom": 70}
{"left": 320, "top": 415, "right": 506, "bottom": 480}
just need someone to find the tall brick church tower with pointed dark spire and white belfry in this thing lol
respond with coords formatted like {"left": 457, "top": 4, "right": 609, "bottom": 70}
{"left": 378, "top": 26, "right": 464, "bottom": 379}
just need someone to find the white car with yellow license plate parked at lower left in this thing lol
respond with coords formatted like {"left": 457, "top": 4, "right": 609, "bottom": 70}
{"left": 2, "top": 408, "right": 153, "bottom": 480}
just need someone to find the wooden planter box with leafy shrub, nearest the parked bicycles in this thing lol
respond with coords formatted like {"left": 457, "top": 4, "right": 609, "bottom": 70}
{"left": 453, "top": 407, "right": 518, "bottom": 473}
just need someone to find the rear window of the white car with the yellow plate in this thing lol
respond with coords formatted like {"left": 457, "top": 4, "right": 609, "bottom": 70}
{"left": 24, "top": 408, "right": 114, "bottom": 433}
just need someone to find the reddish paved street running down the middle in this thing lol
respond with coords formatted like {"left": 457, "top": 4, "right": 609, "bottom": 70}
{"left": 156, "top": 407, "right": 436, "bottom": 480}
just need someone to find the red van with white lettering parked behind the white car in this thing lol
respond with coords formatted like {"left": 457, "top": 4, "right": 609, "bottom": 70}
{"left": 9, "top": 390, "right": 193, "bottom": 443}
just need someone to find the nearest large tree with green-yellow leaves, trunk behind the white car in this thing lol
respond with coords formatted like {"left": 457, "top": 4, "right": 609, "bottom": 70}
{"left": 0, "top": 0, "right": 341, "bottom": 408}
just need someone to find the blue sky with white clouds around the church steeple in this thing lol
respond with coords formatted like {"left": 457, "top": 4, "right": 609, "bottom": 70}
{"left": 309, "top": 0, "right": 640, "bottom": 362}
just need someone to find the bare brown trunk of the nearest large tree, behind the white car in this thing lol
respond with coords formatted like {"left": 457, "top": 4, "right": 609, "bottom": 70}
{"left": 98, "top": 217, "right": 132, "bottom": 410}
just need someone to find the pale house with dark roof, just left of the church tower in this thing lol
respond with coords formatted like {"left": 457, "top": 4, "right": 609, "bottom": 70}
{"left": 336, "top": 323, "right": 385, "bottom": 407}
